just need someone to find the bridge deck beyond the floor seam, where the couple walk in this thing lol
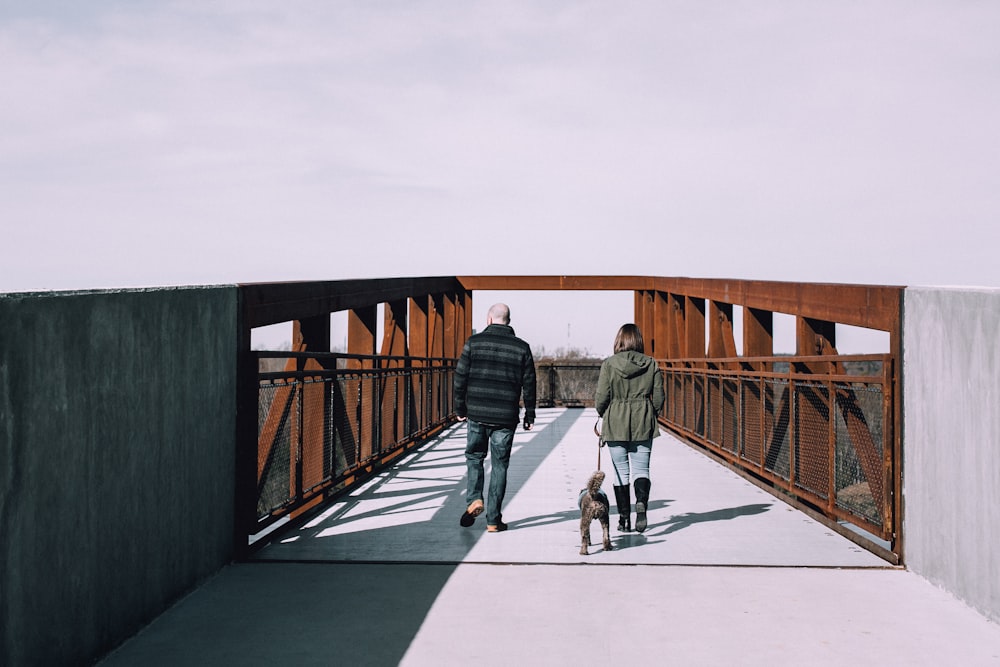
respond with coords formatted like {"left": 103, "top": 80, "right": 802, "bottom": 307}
{"left": 259, "top": 409, "right": 887, "bottom": 567}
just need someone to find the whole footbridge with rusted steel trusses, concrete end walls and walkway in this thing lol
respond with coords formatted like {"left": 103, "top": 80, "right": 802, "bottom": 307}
{"left": 0, "top": 276, "right": 1000, "bottom": 664}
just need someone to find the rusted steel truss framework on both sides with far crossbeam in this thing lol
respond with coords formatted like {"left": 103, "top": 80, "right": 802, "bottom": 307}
{"left": 236, "top": 276, "right": 902, "bottom": 562}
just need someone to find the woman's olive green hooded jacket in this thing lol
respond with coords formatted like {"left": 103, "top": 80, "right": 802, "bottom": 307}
{"left": 594, "top": 350, "right": 663, "bottom": 442}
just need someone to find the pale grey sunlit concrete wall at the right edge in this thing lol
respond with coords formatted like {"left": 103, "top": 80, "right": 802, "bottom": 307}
{"left": 903, "top": 288, "right": 1000, "bottom": 621}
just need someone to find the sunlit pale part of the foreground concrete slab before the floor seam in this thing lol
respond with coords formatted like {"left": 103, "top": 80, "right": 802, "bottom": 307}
{"left": 400, "top": 565, "right": 1000, "bottom": 667}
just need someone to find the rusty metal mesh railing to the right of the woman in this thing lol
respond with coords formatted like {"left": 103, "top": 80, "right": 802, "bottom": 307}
{"left": 660, "top": 355, "right": 897, "bottom": 560}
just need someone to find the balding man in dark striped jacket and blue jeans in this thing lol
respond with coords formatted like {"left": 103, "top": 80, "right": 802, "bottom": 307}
{"left": 455, "top": 303, "right": 535, "bottom": 533}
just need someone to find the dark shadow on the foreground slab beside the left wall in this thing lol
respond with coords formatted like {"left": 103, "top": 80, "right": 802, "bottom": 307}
{"left": 98, "top": 563, "right": 457, "bottom": 667}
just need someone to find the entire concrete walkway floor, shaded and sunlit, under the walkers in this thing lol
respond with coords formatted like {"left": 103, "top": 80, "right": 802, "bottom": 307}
{"left": 101, "top": 409, "right": 1000, "bottom": 667}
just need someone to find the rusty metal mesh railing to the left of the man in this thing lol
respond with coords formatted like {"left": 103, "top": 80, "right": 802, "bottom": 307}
{"left": 255, "top": 352, "right": 454, "bottom": 530}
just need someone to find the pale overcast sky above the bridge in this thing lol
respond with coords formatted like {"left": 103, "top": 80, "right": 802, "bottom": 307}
{"left": 0, "top": 0, "right": 1000, "bottom": 346}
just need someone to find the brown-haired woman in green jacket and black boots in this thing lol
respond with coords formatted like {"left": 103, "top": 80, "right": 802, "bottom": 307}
{"left": 594, "top": 324, "right": 663, "bottom": 533}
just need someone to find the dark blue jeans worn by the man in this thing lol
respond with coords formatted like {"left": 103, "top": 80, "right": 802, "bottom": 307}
{"left": 465, "top": 419, "right": 517, "bottom": 526}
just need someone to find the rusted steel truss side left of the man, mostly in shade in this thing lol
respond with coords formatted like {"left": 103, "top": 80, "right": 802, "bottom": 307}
{"left": 234, "top": 278, "right": 472, "bottom": 553}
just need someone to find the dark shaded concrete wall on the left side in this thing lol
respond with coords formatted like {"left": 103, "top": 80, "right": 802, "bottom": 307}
{"left": 0, "top": 287, "right": 238, "bottom": 666}
